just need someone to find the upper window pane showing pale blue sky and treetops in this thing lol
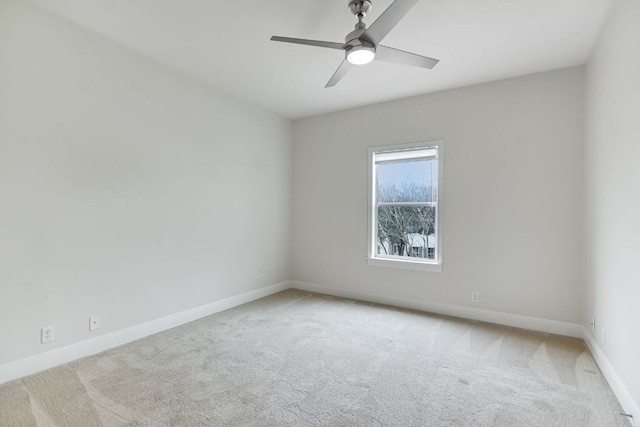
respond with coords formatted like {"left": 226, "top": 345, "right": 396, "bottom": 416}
{"left": 376, "top": 159, "right": 438, "bottom": 203}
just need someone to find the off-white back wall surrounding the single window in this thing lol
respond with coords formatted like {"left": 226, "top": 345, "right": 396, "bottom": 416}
{"left": 293, "top": 67, "right": 584, "bottom": 323}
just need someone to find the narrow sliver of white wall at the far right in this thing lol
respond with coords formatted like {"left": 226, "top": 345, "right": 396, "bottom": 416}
{"left": 584, "top": 0, "right": 640, "bottom": 418}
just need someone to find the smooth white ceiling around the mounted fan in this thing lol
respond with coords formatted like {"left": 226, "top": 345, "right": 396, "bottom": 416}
{"left": 31, "top": 0, "right": 610, "bottom": 118}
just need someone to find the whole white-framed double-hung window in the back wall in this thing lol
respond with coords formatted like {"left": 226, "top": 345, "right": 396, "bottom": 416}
{"left": 368, "top": 141, "right": 443, "bottom": 271}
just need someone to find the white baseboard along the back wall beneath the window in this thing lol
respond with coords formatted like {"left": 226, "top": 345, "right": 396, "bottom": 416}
{"left": 290, "top": 281, "right": 584, "bottom": 338}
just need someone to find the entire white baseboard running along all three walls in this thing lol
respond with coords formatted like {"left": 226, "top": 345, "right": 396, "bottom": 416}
{"left": 0, "top": 281, "right": 640, "bottom": 423}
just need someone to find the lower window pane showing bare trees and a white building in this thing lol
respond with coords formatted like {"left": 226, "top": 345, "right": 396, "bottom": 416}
{"left": 376, "top": 206, "right": 436, "bottom": 259}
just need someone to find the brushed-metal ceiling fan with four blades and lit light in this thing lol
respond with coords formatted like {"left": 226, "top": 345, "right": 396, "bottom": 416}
{"left": 271, "top": 0, "right": 438, "bottom": 87}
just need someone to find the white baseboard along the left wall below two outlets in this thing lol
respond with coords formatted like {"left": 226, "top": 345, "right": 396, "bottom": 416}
{"left": 0, "top": 282, "right": 290, "bottom": 384}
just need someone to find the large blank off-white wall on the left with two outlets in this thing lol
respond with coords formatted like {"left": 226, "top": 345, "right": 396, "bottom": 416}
{"left": 0, "top": 0, "right": 292, "bottom": 365}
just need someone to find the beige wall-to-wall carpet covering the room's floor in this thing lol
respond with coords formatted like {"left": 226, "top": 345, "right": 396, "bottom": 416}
{"left": 0, "top": 290, "right": 629, "bottom": 427}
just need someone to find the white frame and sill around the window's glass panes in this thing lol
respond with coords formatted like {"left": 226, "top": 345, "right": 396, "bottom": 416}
{"left": 367, "top": 140, "right": 444, "bottom": 273}
